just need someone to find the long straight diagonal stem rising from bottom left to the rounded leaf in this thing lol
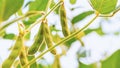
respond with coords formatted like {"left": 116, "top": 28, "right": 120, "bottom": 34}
{"left": 23, "top": 14, "right": 99, "bottom": 68}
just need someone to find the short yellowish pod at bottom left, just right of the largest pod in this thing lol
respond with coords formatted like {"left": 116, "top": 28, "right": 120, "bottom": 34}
{"left": 19, "top": 46, "right": 29, "bottom": 68}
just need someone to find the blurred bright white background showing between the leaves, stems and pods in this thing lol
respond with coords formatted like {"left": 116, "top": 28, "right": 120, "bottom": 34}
{"left": 0, "top": 0, "right": 120, "bottom": 68}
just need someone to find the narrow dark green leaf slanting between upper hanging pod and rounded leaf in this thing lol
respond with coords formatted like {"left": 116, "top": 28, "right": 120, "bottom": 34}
{"left": 72, "top": 11, "right": 94, "bottom": 24}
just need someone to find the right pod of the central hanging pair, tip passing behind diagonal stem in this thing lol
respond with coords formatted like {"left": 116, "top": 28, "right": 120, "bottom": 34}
{"left": 42, "top": 20, "right": 56, "bottom": 55}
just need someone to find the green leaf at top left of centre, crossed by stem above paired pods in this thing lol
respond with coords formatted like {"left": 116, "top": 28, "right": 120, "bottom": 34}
{"left": 24, "top": 0, "right": 49, "bottom": 27}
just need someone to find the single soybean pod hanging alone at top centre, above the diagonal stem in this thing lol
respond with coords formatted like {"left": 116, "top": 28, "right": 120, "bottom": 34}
{"left": 59, "top": 3, "right": 70, "bottom": 37}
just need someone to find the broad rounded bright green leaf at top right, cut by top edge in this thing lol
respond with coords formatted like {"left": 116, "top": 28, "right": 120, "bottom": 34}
{"left": 90, "top": 0, "right": 118, "bottom": 14}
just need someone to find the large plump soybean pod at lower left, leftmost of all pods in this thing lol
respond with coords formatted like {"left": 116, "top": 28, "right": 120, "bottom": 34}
{"left": 2, "top": 34, "right": 23, "bottom": 68}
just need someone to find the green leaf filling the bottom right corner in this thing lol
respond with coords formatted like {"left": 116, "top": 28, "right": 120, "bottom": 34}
{"left": 101, "top": 50, "right": 120, "bottom": 68}
